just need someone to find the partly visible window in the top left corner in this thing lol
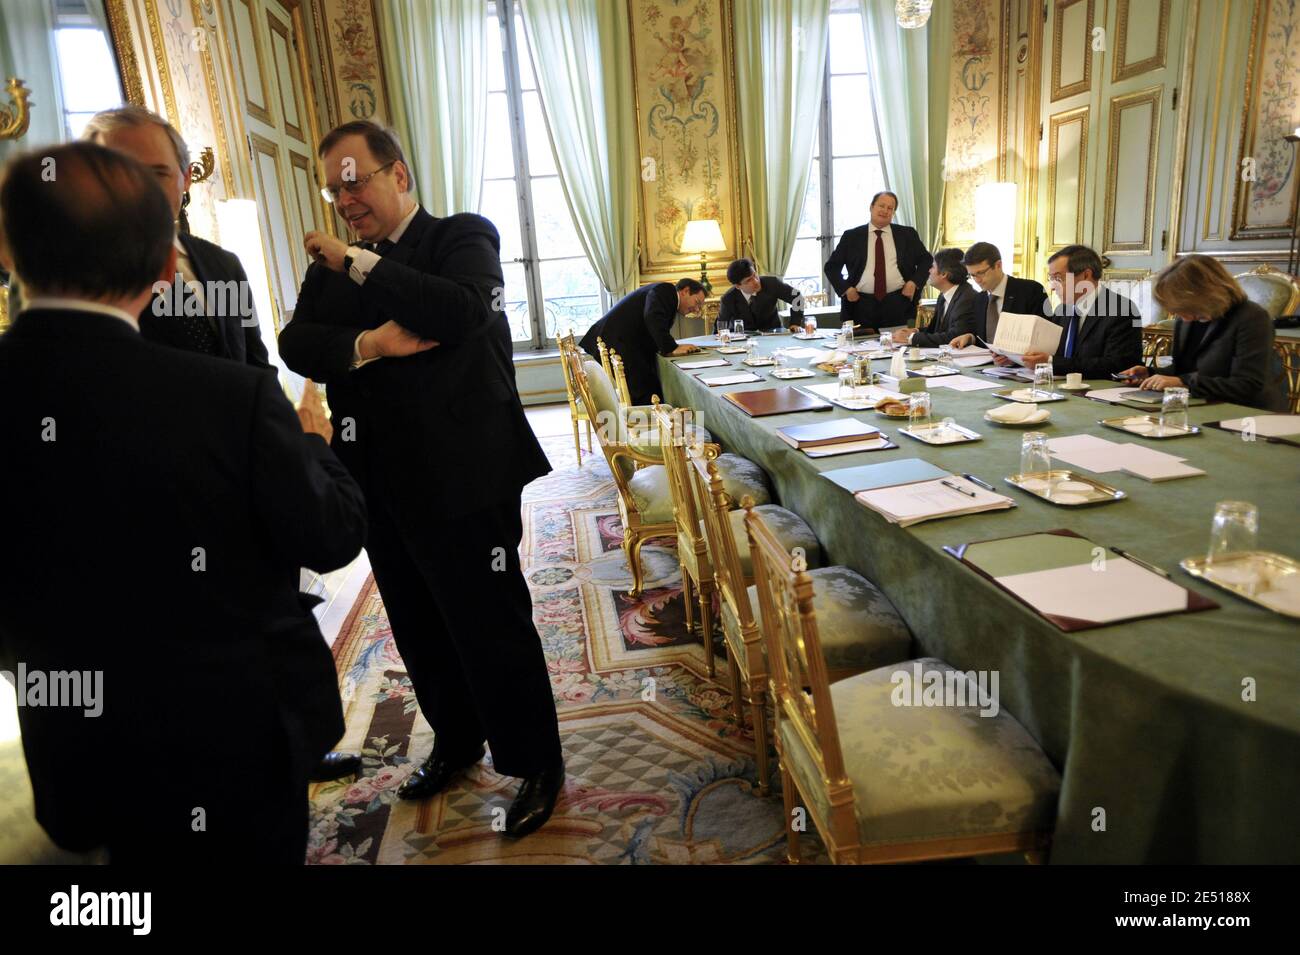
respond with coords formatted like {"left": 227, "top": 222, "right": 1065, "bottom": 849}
{"left": 55, "top": 0, "right": 122, "bottom": 139}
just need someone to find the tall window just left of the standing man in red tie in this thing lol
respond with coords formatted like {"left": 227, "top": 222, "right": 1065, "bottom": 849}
{"left": 785, "top": 0, "right": 889, "bottom": 300}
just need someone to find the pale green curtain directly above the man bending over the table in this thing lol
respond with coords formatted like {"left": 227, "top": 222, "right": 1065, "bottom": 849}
{"left": 520, "top": 0, "right": 641, "bottom": 298}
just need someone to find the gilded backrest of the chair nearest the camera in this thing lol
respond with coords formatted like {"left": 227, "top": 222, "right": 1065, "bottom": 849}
{"left": 745, "top": 505, "right": 848, "bottom": 787}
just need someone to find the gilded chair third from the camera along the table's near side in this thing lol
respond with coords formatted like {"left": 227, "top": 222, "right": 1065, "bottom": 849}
{"left": 654, "top": 398, "right": 822, "bottom": 678}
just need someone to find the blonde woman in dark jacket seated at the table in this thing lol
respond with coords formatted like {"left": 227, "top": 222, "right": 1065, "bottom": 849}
{"left": 1119, "top": 255, "right": 1287, "bottom": 412}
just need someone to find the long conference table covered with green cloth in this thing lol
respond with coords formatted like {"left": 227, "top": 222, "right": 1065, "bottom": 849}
{"left": 659, "top": 335, "right": 1300, "bottom": 864}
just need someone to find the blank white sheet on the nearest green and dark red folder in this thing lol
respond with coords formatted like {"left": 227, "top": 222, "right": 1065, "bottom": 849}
{"left": 997, "top": 556, "right": 1187, "bottom": 624}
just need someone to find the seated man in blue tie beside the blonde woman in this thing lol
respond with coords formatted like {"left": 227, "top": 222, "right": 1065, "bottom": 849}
{"left": 1024, "top": 246, "right": 1141, "bottom": 379}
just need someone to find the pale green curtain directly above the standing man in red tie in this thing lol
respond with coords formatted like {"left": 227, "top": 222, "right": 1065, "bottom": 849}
{"left": 858, "top": 0, "right": 948, "bottom": 242}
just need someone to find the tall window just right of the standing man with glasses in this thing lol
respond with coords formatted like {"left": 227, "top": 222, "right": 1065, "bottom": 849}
{"left": 480, "top": 0, "right": 607, "bottom": 350}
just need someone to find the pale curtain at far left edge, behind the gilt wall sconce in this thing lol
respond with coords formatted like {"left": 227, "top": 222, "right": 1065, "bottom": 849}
{"left": 0, "top": 0, "right": 64, "bottom": 162}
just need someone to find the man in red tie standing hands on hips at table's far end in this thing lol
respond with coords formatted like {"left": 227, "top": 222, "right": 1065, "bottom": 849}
{"left": 823, "top": 192, "right": 933, "bottom": 334}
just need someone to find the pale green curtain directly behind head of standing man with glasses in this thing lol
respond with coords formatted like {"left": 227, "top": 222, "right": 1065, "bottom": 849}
{"left": 376, "top": 0, "right": 488, "bottom": 216}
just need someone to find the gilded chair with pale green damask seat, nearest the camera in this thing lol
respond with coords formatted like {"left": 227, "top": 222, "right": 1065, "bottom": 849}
{"left": 745, "top": 509, "right": 1061, "bottom": 863}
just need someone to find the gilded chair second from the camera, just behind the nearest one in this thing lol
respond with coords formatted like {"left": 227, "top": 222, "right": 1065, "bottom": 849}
{"left": 686, "top": 444, "right": 911, "bottom": 794}
